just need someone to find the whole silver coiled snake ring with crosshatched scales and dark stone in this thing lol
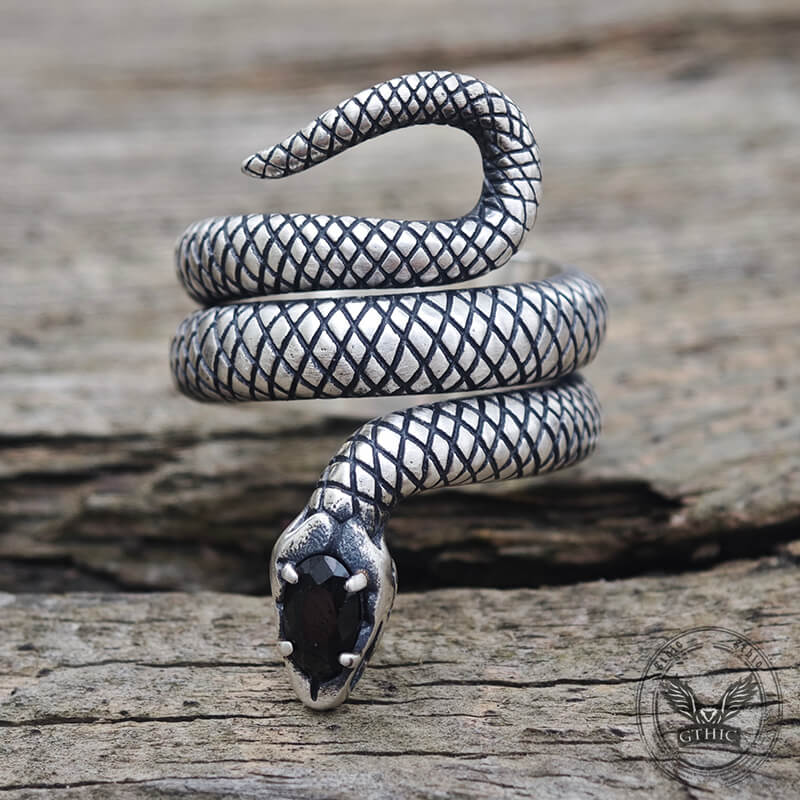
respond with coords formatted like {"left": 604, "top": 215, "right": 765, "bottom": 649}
{"left": 171, "top": 71, "right": 607, "bottom": 709}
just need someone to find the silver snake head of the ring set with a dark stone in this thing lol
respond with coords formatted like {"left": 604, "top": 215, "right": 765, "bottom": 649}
{"left": 270, "top": 509, "right": 397, "bottom": 709}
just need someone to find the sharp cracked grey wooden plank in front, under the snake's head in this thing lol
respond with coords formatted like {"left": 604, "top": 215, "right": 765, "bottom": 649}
{"left": 0, "top": 559, "right": 800, "bottom": 800}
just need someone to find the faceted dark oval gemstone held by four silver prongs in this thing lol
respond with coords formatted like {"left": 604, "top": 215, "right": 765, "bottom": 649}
{"left": 283, "top": 556, "right": 361, "bottom": 684}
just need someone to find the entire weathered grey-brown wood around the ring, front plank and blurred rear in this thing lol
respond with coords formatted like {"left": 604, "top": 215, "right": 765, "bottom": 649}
{"left": 0, "top": 0, "right": 800, "bottom": 798}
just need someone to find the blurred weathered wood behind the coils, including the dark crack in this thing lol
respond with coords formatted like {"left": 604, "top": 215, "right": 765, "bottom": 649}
{"left": 0, "top": 0, "right": 800, "bottom": 592}
